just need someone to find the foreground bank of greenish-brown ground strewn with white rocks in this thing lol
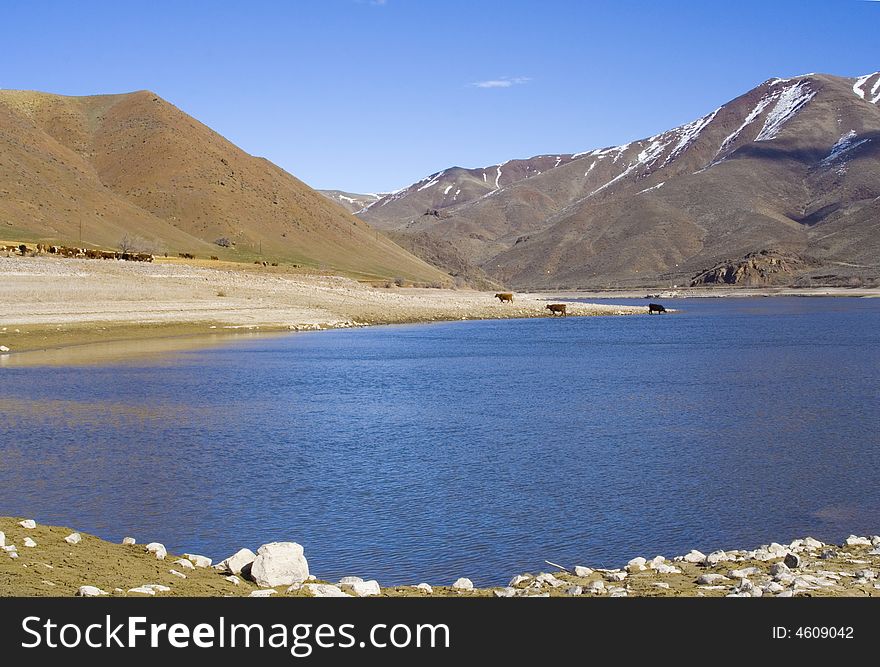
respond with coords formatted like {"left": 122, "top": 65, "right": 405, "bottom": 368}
{"left": 0, "top": 517, "right": 880, "bottom": 597}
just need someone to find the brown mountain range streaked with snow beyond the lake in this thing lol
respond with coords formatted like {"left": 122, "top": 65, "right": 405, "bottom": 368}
{"left": 358, "top": 72, "right": 880, "bottom": 287}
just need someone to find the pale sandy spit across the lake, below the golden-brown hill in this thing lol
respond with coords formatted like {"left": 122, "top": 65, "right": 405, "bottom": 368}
{"left": 0, "top": 257, "right": 646, "bottom": 366}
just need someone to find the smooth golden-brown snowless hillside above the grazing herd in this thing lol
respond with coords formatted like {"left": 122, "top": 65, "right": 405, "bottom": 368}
{"left": 0, "top": 91, "right": 448, "bottom": 281}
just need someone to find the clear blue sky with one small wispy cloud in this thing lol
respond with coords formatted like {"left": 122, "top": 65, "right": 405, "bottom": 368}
{"left": 0, "top": 0, "right": 880, "bottom": 192}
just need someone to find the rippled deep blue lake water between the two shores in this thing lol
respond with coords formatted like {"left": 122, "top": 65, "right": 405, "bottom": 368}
{"left": 0, "top": 298, "right": 880, "bottom": 585}
